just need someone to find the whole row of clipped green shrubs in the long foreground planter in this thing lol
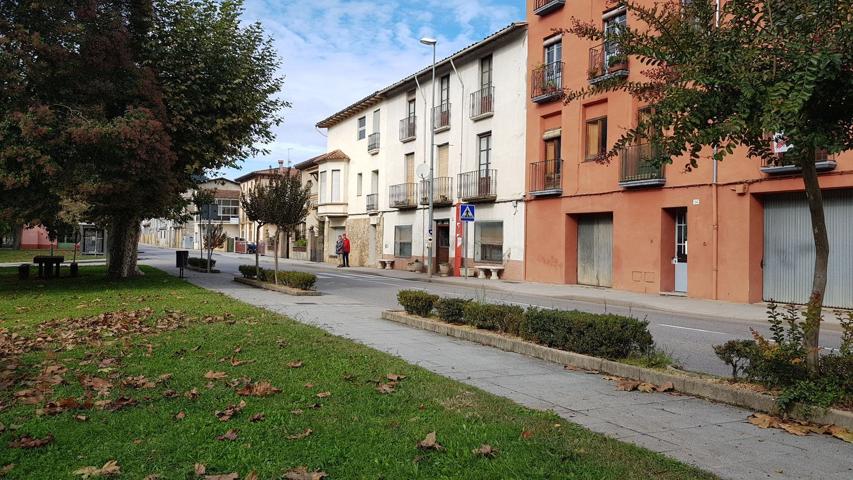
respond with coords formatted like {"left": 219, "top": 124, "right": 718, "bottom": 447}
{"left": 397, "top": 290, "right": 654, "bottom": 359}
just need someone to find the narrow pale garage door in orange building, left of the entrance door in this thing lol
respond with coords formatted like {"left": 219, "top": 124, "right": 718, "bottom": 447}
{"left": 578, "top": 213, "right": 613, "bottom": 287}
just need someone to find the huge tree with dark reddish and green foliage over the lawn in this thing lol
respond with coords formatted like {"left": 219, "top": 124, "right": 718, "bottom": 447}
{"left": 0, "top": 0, "right": 287, "bottom": 277}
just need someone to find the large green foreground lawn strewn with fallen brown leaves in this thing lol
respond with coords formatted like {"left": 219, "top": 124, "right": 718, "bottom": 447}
{"left": 0, "top": 267, "right": 714, "bottom": 480}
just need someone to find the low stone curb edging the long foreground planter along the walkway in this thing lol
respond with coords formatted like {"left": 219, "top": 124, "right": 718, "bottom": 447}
{"left": 382, "top": 310, "right": 853, "bottom": 429}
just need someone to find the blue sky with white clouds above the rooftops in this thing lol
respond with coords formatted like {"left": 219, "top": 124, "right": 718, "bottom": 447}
{"left": 216, "top": 0, "right": 525, "bottom": 178}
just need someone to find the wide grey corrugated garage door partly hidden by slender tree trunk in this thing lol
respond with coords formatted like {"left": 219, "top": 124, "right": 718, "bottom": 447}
{"left": 764, "top": 190, "right": 853, "bottom": 308}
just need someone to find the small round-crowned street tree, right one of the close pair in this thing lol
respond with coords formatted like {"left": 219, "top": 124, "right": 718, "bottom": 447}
{"left": 268, "top": 168, "right": 311, "bottom": 283}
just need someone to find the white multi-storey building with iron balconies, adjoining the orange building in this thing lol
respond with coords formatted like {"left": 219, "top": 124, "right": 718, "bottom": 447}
{"left": 313, "top": 22, "right": 527, "bottom": 279}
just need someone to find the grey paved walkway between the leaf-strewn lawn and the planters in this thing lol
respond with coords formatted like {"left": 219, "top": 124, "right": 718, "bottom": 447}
{"left": 141, "top": 253, "right": 853, "bottom": 480}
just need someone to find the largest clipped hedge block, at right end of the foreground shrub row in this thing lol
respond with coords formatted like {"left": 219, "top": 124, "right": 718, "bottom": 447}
{"left": 521, "top": 308, "right": 654, "bottom": 358}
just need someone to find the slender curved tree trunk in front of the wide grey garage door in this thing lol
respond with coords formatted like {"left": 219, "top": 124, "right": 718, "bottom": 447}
{"left": 802, "top": 149, "right": 829, "bottom": 373}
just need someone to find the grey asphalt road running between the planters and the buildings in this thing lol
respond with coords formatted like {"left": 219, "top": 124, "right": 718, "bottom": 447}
{"left": 140, "top": 245, "right": 841, "bottom": 375}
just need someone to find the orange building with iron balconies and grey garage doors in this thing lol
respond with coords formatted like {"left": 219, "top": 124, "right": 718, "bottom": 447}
{"left": 524, "top": 0, "right": 853, "bottom": 308}
